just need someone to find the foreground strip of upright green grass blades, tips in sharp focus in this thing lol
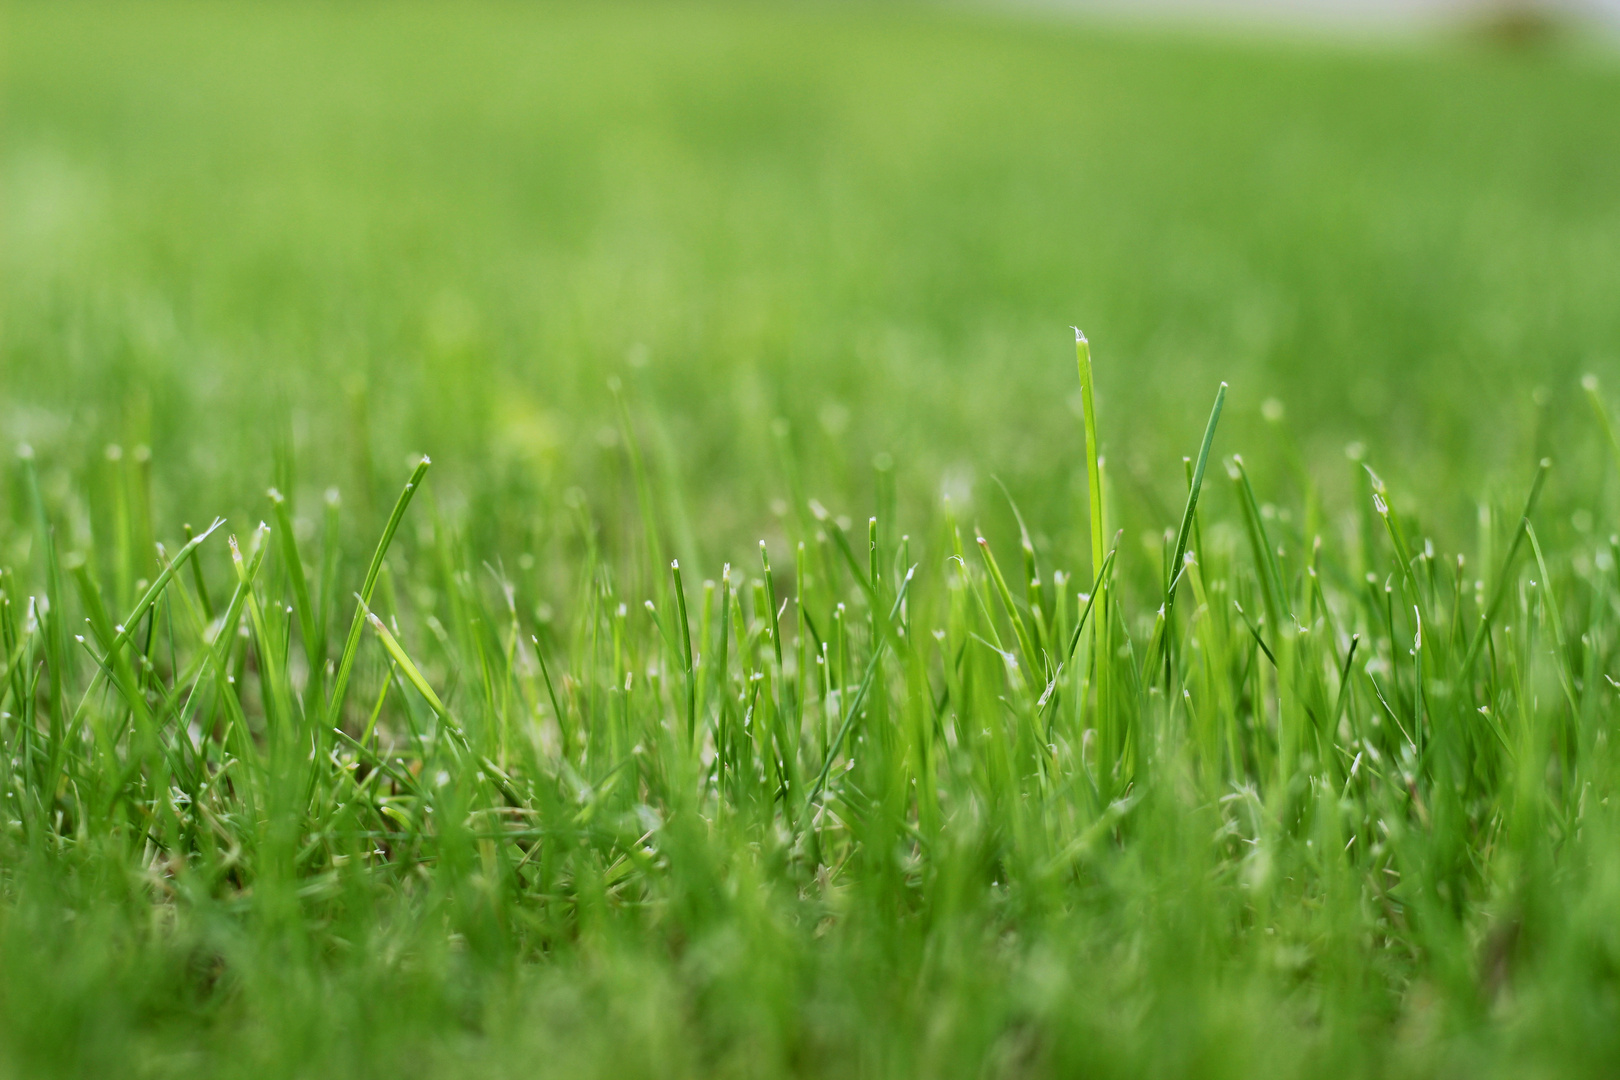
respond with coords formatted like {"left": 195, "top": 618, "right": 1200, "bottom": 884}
{"left": 0, "top": 351, "right": 1620, "bottom": 1075}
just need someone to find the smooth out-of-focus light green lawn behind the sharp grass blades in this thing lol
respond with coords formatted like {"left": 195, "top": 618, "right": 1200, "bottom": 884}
{"left": 0, "top": 3, "right": 1620, "bottom": 560}
